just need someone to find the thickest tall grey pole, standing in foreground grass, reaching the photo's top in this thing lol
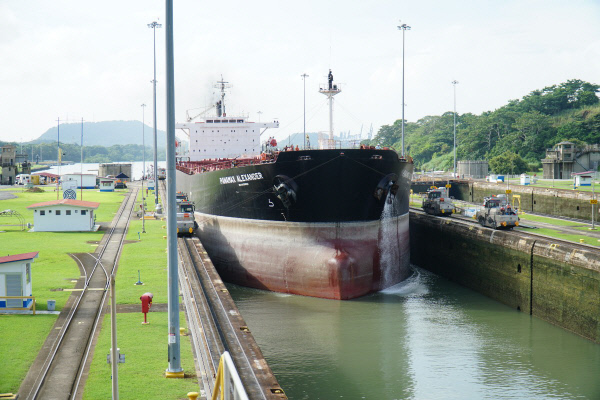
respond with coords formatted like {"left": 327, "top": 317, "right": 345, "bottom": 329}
{"left": 165, "top": 0, "right": 184, "bottom": 378}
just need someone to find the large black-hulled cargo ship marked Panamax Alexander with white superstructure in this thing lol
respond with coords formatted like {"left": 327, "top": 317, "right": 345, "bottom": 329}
{"left": 176, "top": 76, "right": 413, "bottom": 300}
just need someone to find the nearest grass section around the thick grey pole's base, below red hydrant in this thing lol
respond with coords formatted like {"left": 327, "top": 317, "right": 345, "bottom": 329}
{"left": 83, "top": 312, "right": 199, "bottom": 400}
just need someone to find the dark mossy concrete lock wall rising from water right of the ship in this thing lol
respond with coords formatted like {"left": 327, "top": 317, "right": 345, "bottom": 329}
{"left": 410, "top": 213, "right": 600, "bottom": 343}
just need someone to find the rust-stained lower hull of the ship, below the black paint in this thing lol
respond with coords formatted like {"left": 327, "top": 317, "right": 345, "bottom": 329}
{"left": 196, "top": 213, "right": 410, "bottom": 300}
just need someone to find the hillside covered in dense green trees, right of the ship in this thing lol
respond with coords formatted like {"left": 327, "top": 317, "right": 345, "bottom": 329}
{"left": 370, "top": 79, "right": 600, "bottom": 173}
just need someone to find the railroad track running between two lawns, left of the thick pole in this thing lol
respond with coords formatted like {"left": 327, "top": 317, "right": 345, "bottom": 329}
{"left": 25, "top": 188, "right": 138, "bottom": 400}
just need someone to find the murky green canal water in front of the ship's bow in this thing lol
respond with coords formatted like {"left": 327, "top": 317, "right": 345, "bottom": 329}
{"left": 229, "top": 268, "right": 600, "bottom": 400}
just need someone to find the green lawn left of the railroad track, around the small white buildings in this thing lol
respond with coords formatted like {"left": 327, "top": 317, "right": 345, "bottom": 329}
{"left": 0, "top": 190, "right": 123, "bottom": 393}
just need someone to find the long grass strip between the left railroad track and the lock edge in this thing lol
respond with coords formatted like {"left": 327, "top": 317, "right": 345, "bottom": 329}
{"left": 84, "top": 205, "right": 199, "bottom": 400}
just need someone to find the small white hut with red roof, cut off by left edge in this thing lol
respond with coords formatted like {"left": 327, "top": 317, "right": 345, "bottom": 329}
{"left": 0, "top": 251, "right": 38, "bottom": 311}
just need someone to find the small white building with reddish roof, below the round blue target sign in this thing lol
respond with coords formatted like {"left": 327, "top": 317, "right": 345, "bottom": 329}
{"left": 27, "top": 199, "right": 100, "bottom": 232}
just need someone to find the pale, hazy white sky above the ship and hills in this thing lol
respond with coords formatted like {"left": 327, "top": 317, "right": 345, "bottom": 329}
{"left": 0, "top": 0, "right": 600, "bottom": 142}
